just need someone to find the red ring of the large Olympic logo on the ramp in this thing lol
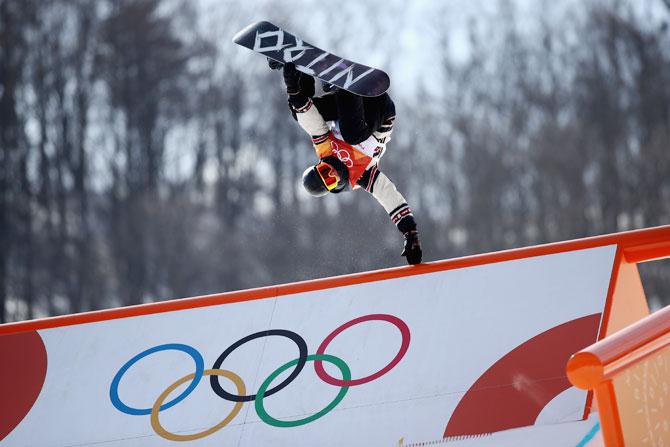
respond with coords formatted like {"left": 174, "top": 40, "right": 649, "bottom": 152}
{"left": 314, "top": 314, "right": 410, "bottom": 386}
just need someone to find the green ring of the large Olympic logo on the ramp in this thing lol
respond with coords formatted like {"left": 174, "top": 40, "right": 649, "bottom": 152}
{"left": 255, "top": 354, "right": 351, "bottom": 427}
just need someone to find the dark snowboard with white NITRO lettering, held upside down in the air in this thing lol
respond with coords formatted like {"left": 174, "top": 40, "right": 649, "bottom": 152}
{"left": 233, "top": 21, "right": 390, "bottom": 96}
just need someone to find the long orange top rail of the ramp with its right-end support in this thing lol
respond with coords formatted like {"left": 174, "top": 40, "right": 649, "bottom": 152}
{"left": 0, "top": 225, "right": 670, "bottom": 338}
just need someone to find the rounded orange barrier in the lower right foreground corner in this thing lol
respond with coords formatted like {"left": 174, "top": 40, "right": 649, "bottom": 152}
{"left": 567, "top": 307, "right": 670, "bottom": 446}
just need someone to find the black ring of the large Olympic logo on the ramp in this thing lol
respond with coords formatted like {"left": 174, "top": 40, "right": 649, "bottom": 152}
{"left": 209, "top": 329, "right": 307, "bottom": 402}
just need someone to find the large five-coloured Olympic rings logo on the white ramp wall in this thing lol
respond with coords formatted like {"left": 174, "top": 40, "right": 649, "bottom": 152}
{"left": 109, "top": 314, "right": 410, "bottom": 441}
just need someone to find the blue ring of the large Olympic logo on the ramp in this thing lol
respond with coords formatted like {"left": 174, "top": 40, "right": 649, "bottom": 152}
{"left": 109, "top": 343, "right": 205, "bottom": 416}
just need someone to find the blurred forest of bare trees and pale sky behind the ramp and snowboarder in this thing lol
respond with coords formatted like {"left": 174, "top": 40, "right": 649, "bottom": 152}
{"left": 0, "top": 0, "right": 670, "bottom": 322}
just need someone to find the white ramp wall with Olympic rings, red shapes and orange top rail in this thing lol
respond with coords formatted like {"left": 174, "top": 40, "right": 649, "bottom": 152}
{"left": 0, "top": 227, "right": 670, "bottom": 447}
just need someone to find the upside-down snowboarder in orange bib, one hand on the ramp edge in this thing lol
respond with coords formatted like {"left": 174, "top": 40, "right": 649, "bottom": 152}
{"left": 269, "top": 60, "right": 422, "bottom": 264}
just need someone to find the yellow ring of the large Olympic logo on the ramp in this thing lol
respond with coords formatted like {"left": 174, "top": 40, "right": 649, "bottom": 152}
{"left": 151, "top": 369, "right": 247, "bottom": 441}
